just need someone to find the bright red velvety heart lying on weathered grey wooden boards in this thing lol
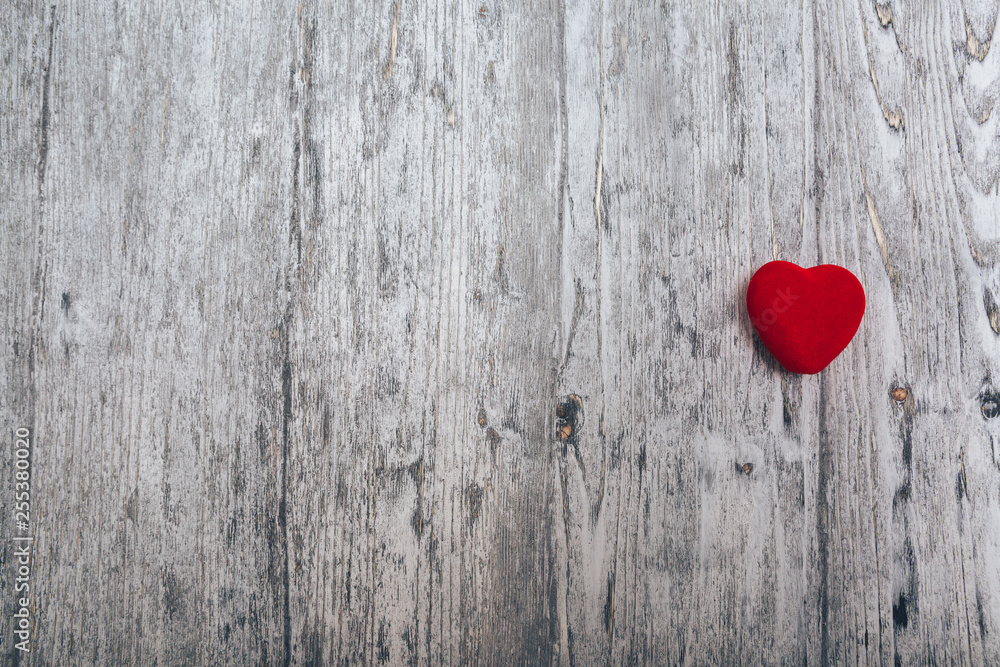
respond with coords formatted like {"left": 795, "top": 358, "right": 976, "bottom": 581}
{"left": 747, "top": 262, "right": 865, "bottom": 374}
